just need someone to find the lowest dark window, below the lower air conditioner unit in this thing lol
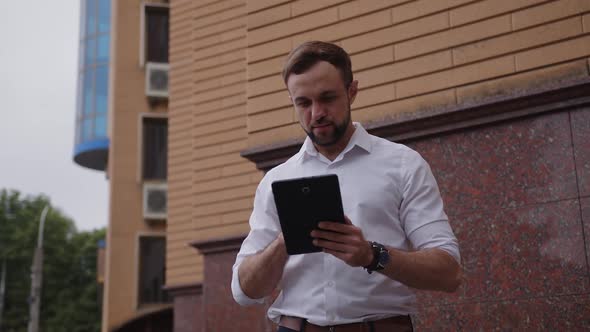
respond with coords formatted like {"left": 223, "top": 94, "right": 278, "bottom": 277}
{"left": 138, "top": 236, "right": 169, "bottom": 306}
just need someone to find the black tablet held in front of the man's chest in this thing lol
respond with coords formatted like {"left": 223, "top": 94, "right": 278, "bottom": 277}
{"left": 272, "top": 174, "right": 344, "bottom": 255}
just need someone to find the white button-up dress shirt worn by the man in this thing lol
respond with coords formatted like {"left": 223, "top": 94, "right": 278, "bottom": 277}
{"left": 231, "top": 123, "right": 460, "bottom": 326}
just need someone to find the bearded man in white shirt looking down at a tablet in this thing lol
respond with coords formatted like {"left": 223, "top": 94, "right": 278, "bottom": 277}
{"left": 231, "top": 42, "right": 461, "bottom": 332}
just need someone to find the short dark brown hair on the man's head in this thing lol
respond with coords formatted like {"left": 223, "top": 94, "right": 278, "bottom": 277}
{"left": 283, "top": 41, "right": 352, "bottom": 87}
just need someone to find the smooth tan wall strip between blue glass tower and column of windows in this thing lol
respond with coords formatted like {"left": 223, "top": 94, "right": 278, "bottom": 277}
{"left": 102, "top": 0, "right": 166, "bottom": 331}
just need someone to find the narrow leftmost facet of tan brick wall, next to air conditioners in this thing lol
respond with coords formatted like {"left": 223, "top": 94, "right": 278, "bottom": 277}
{"left": 166, "top": 0, "right": 201, "bottom": 284}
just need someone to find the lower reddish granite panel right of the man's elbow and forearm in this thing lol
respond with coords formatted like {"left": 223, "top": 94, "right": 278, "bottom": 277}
{"left": 419, "top": 200, "right": 590, "bottom": 304}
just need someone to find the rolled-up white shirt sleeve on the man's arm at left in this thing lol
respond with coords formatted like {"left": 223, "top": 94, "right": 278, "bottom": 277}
{"left": 231, "top": 174, "right": 280, "bottom": 305}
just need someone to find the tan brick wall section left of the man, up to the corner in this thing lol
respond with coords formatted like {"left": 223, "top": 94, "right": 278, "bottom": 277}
{"left": 166, "top": 0, "right": 261, "bottom": 285}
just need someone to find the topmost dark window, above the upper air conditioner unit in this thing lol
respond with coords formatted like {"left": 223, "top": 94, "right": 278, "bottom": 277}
{"left": 144, "top": 6, "right": 169, "bottom": 63}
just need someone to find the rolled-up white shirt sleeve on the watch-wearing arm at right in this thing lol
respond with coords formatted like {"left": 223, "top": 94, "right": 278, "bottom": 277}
{"left": 400, "top": 150, "right": 461, "bottom": 262}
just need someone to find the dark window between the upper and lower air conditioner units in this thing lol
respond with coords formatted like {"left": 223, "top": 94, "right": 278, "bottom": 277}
{"left": 142, "top": 117, "right": 168, "bottom": 180}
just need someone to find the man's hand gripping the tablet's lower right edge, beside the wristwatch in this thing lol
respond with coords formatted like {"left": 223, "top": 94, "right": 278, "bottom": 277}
{"left": 311, "top": 216, "right": 373, "bottom": 267}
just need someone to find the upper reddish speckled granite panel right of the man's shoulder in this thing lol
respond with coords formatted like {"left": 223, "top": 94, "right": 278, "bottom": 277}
{"left": 408, "top": 113, "right": 577, "bottom": 216}
